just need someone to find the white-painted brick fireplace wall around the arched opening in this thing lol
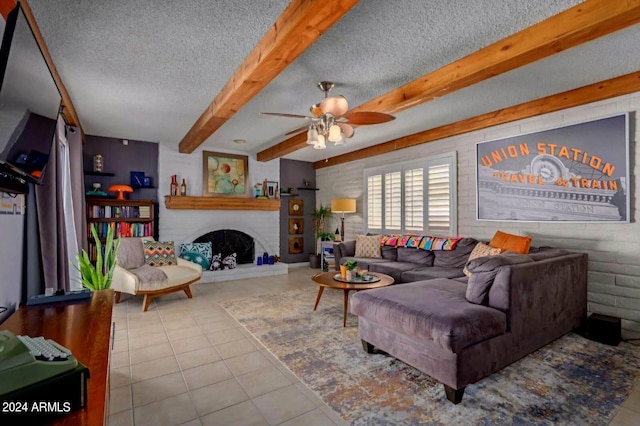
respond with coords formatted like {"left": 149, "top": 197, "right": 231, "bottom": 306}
{"left": 156, "top": 144, "right": 280, "bottom": 260}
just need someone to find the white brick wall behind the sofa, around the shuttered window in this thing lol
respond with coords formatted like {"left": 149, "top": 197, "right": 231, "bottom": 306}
{"left": 317, "top": 92, "right": 640, "bottom": 335}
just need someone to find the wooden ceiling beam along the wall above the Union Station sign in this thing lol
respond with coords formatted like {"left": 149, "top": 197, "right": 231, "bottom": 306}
{"left": 313, "top": 71, "right": 640, "bottom": 169}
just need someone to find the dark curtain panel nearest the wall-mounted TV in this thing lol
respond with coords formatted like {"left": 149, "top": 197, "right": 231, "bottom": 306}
{"left": 36, "top": 119, "right": 70, "bottom": 291}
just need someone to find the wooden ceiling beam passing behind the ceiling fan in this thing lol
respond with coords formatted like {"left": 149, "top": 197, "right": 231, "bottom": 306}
{"left": 257, "top": 0, "right": 640, "bottom": 161}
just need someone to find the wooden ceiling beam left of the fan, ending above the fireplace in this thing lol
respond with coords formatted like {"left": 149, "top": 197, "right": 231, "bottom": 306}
{"left": 178, "top": 0, "right": 358, "bottom": 154}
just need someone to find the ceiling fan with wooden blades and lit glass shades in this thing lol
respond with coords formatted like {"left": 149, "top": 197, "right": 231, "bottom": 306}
{"left": 261, "top": 81, "right": 395, "bottom": 149}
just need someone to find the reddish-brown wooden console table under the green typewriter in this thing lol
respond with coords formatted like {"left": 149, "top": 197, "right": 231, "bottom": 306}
{"left": 0, "top": 290, "right": 113, "bottom": 425}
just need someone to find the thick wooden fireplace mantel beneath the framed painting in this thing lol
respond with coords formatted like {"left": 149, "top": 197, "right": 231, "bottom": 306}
{"left": 164, "top": 195, "right": 280, "bottom": 211}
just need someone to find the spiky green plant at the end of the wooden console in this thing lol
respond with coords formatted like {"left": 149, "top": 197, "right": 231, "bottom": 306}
{"left": 74, "top": 223, "right": 120, "bottom": 291}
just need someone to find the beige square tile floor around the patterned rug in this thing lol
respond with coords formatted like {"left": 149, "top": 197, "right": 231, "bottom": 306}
{"left": 109, "top": 267, "right": 640, "bottom": 426}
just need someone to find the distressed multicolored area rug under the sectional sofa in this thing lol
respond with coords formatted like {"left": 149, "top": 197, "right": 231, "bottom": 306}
{"left": 220, "top": 286, "right": 640, "bottom": 425}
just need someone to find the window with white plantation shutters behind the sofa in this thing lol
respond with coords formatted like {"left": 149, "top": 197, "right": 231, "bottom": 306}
{"left": 364, "top": 152, "right": 457, "bottom": 236}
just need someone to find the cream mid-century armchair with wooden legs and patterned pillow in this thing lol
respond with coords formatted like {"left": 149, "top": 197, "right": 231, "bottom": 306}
{"left": 111, "top": 237, "right": 202, "bottom": 312}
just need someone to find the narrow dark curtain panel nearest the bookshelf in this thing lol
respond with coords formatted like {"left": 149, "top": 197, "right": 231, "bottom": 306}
{"left": 66, "top": 126, "right": 88, "bottom": 253}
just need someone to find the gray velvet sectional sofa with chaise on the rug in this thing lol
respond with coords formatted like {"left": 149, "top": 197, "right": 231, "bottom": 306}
{"left": 336, "top": 239, "right": 587, "bottom": 404}
